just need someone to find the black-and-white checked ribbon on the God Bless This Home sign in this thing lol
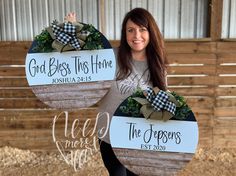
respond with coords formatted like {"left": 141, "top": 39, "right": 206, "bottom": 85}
{"left": 52, "top": 23, "right": 80, "bottom": 49}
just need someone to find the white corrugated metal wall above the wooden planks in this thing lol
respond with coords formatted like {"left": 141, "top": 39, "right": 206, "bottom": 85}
{"left": 0, "top": 0, "right": 232, "bottom": 41}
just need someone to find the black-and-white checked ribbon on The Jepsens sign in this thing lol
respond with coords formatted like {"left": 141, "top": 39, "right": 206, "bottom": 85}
{"left": 146, "top": 87, "right": 176, "bottom": 114}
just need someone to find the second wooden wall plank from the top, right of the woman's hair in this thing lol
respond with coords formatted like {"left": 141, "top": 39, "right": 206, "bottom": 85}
{"left": 167, "top": 53, "right": 216, "bottom": 65}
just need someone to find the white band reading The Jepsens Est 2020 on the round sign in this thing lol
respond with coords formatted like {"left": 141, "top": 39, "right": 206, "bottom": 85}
{"left": 110, "top": 116, "right": 198, "bottom": 153}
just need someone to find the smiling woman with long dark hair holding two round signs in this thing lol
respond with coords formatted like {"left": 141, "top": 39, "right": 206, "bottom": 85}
{"left": 66, "top": 8, "right": 167, "bottom": 176}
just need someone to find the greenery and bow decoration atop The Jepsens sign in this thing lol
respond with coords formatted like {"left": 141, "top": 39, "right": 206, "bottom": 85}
{"left": 119, "top": 87, "right": 191, "bottom": 121}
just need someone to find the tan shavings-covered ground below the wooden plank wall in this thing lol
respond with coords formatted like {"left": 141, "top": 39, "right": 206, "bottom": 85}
{"left": 0, "top": 147, "right": 236, "bottom": 176}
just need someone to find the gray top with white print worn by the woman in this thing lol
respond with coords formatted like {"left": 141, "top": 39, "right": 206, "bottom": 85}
{"left": 97, "top": 55, "right": 151, "bottom": 143}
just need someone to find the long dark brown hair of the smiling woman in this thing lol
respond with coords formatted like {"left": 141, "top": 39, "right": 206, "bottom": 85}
{"left": 117, "top": 8, "right": 167, "bottom": 90}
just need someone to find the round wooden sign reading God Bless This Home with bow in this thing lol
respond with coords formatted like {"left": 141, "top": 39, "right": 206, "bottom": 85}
{"left": 25, "top": 23, "right": 116, "bottom": 109}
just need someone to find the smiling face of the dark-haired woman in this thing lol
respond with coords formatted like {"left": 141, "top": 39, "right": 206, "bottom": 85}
{"left": 126, "top": 19, "right": 149, "bottom": 52}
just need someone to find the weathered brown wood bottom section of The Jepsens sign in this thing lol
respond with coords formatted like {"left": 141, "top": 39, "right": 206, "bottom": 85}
{"left": 113, "top": 148, "right": 193, "bottom": 176}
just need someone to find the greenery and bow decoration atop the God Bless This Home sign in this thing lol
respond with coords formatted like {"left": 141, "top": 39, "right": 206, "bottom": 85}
{"left": 32, "top": 20, "right": 104, "bottom": 52}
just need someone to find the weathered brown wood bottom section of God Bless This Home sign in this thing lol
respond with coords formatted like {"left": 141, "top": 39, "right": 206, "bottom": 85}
{"left": 32, "top": 81, "right": 111, "bottom": 109}
